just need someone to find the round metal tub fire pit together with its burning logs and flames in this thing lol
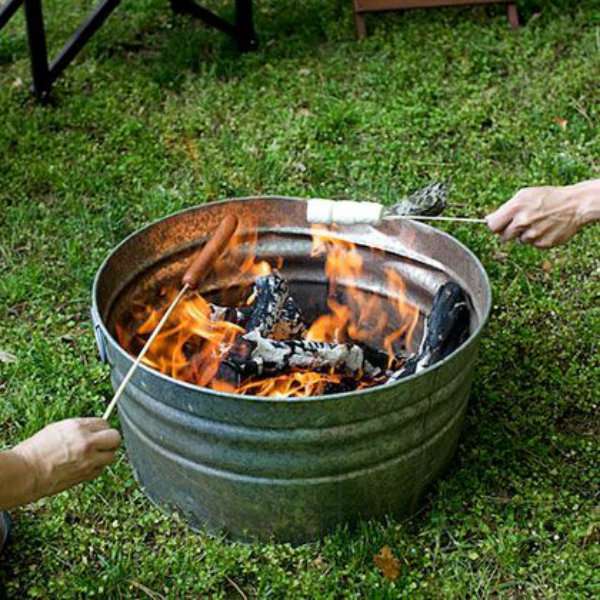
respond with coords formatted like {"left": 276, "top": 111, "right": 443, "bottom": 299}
{"left": 92, "top": 198, "right": 490, "bottom": 542}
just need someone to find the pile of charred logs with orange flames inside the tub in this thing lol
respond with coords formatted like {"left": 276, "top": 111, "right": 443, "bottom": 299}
{"left": 116, "top": 230, "right": 470, "bottom": 397}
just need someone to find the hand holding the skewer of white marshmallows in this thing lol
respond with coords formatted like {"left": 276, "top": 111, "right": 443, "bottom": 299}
{"left": 486, "top": 181, "right": 599, "bottom": 248}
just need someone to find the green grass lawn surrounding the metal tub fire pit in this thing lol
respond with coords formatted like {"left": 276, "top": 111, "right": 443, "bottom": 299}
{"left": 0, "top": 0, "right": 600, "bottom": 598}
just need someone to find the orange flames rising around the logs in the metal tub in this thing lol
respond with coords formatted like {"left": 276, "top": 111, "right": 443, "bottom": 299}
{"left": 116, "top": 226, "right": 419, "bottom": 398}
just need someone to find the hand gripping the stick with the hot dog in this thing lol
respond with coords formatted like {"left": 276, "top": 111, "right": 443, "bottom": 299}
{"left": 12, "top": 417, "right": 121, "bottom": 501}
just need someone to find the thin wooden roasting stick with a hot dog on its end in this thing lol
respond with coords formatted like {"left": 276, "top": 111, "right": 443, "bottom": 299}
{"left": 102, "top": 215, "right": 238, "bottom": 420}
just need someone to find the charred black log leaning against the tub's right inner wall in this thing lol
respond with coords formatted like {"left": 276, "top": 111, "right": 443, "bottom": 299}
{"left": 388, "top": 281, "right": 470, "bottom": 383}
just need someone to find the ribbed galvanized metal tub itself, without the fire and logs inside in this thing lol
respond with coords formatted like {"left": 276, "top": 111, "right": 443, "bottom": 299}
{"left": 92, "top": 197, "right": 491, "bottom": 543}
